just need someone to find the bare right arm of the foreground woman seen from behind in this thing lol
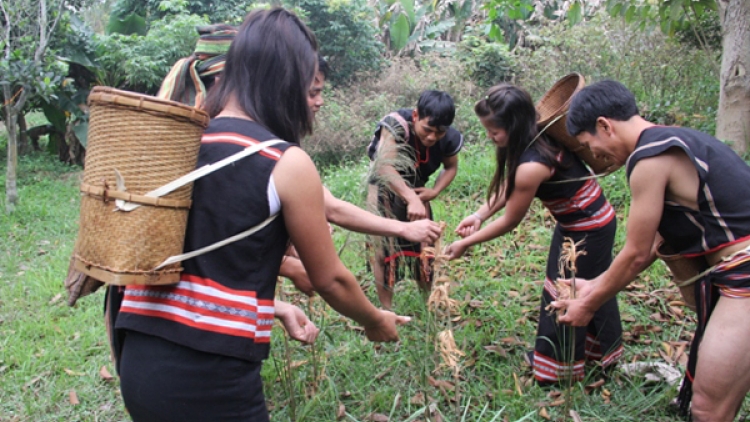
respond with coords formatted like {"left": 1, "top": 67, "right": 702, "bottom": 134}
{"left": 273, "top": 148, "right": 404, "bottom": 341}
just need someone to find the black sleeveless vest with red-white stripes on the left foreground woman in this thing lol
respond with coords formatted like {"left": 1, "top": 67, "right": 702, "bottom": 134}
{"left": 117, "top": 118, "right": 291, "bottom": 361}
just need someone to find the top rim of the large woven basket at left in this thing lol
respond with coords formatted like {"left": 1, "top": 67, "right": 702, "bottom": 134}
{"left": 87, "top": 86, "right": 210, "bottom": 129}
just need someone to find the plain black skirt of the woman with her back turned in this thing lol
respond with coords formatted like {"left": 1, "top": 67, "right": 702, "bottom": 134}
{"left": 120, "top": 330, "right": 269, "bottom": 422}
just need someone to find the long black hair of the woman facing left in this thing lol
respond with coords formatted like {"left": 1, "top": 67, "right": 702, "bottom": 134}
{"left": 474, "top": 84, "right": 559, "bottom": 205}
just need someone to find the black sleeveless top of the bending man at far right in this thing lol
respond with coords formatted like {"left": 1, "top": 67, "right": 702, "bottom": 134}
{"left": 626, "top": 126, "right": 750, "bottom": 256}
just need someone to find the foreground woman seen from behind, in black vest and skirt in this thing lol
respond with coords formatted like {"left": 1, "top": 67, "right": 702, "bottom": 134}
{"left": 116, "top": 9, "right": 408, "bottom": 422}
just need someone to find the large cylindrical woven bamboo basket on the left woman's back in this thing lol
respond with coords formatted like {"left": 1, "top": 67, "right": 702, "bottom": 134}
{"left": 74, "top": 87, "right": 209, "bottom": 285}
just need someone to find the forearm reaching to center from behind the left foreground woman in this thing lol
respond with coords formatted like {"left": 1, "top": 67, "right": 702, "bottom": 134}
{"left": 323, "top": 187, "right": 440, "bottom": 242}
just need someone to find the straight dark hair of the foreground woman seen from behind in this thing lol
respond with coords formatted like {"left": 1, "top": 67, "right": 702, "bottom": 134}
{"left": 205, "top": 8, "right": 318, "bottom": 143}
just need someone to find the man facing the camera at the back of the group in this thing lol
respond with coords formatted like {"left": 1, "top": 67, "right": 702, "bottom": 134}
{"left": 367, "top": 91, "right": 464, "bottom": 309}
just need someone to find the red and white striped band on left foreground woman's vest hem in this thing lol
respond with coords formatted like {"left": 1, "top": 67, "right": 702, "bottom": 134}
{"left": 120, "top": 274, "right": 274, "bottom": 343}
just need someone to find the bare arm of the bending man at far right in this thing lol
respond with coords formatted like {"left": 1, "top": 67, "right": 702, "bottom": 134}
{"left": 556, "top": 156, "right": 676, "bottom": 326}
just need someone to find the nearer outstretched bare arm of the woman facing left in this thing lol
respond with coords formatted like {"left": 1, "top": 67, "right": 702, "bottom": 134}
{"left": 446, "top": 163, "right": 550, "bottom": 259}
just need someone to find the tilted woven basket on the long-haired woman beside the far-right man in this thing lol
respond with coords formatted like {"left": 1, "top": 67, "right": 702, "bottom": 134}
{"left": 536, "top": 73, "right": 617, "bottom": 174}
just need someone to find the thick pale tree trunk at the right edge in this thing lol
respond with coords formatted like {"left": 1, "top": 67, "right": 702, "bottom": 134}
{"left": 716, "top": 0, "right": 750, "bottom": 154}
